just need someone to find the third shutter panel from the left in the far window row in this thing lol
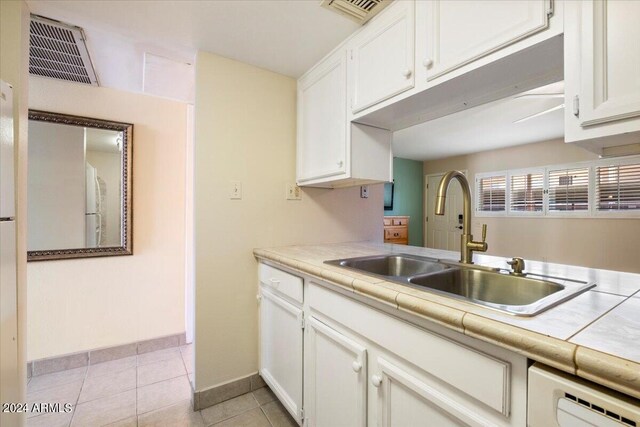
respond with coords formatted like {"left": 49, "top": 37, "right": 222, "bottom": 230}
{"left": 549, "top": 167, "right": 589, "bottom": 212}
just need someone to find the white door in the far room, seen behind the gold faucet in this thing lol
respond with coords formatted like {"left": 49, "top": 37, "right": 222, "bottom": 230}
{"left": 424, "top": 171, "right": 467, "bottom": 251}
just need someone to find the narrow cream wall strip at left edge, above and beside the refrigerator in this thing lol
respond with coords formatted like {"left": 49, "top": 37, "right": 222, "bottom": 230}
{"left": 0, "top": 0, "right": 29, "bottom": 426}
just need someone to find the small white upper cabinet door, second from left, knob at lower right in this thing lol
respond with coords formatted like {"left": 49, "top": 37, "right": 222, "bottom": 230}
{"left": 349, "top": 1, "right": 415, "bottom": 113}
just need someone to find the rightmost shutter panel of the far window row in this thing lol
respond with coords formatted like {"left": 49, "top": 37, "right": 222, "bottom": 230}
{"left": 596, "top": 163, "right": 640, "bottom": 212}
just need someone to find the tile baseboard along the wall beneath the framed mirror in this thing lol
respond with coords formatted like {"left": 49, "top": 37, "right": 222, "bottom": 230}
{"left": 27, "top": 332, "right": 186, "bottom": 378}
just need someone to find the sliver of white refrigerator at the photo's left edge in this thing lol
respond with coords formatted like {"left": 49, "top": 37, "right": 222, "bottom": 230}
{"left": 0, "top": 80, "right": 20, "bottom": 425}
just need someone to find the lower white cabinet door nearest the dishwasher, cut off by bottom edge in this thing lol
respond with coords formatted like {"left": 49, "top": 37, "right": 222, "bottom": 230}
{"left": 370, "top": 358, "right": 493, "bottom": 427}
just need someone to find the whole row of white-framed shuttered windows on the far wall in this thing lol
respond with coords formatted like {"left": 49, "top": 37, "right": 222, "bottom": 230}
{"left": 475, "top": 156, "right": 640, "bottom": 218}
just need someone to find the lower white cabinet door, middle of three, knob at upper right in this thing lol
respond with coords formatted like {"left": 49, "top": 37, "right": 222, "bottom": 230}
{"left": 305, "top": 317, "right": 367, "bottom": 427}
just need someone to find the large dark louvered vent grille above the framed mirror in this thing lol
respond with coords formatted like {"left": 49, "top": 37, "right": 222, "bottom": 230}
{"left": 29, "top": 15, "right": 98, "bottom": 86}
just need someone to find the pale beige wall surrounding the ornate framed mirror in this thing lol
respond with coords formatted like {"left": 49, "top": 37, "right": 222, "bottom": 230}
{"left": 28, "top": 77, "right": 187, "bottom": 360}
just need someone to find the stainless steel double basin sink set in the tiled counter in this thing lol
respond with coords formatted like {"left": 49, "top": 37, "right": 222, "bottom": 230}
{"left": 325, "top": 254, "right": 595, "bottom": 316}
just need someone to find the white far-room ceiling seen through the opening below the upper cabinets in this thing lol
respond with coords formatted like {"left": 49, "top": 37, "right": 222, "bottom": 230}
{"left": 393, "top": 82, "right": 564, "bottom": 160}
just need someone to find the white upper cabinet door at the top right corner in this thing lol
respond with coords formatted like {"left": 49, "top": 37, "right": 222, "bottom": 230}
{"left": 576, "top": 0, "right": 640, "bottom": 126}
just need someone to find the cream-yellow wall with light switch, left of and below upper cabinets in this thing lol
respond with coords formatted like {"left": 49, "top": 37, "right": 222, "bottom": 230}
{"left": 195, "top": 52, "right": 383, "bottom": 390}
